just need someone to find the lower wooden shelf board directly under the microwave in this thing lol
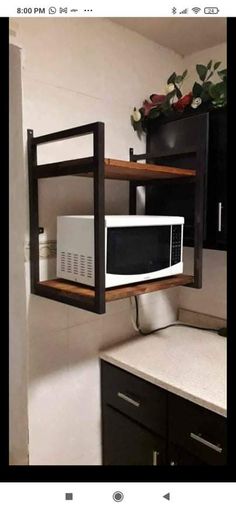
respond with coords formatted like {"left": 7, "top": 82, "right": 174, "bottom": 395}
{"left": 37, "top": 273, "right": 193, "bottom": 302}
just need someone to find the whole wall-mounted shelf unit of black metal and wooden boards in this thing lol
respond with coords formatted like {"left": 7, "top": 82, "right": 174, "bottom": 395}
{"left": 28, "top": 122, "right": 204, "bottom": 314}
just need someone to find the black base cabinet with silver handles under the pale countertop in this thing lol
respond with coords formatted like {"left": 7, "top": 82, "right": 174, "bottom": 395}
{"left": 101, "top": 361, "right": 226, "bottom": 466}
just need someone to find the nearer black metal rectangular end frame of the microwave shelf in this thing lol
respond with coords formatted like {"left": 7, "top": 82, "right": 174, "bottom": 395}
{"left": 27, "top": 122, "right": 105, "bottom": 314}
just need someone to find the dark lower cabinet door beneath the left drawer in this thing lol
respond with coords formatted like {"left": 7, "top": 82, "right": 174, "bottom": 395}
{"left": 103, "top": 405, "right": 165, "bottom": 466}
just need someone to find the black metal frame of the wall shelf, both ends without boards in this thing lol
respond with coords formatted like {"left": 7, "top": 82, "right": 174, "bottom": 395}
{"left": 27, "top": 122, "right": 206, "bottom": 314}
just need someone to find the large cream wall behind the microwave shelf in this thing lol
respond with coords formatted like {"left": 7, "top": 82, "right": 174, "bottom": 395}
{"left": 12, "top": 18, "right": 183, "bottom": 465}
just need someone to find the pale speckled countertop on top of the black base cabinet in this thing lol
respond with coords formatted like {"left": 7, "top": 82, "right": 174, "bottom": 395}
{"left": 100, "top": 326, "right": 227, "bottom": 417}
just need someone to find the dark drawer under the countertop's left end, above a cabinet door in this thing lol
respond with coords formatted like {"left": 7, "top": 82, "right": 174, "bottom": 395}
{"left": 101, "top": 361, "right": 167, "bottom": 437}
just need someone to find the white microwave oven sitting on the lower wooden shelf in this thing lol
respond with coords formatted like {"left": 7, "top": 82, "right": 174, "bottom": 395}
{"left": 57, "top": 215, "right": 184, "bottom": 288}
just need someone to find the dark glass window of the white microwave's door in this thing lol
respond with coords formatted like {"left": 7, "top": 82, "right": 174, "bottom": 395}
{"left": 107, "top": 225, "right": 170, "bottom": 275}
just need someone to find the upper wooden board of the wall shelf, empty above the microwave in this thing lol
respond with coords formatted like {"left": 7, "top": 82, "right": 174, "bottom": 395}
{"left": 35, "top": 157, "right": 196, "bottom": 181}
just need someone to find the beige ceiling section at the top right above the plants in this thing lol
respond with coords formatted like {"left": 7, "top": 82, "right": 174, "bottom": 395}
{"left": 110, "top": 17, "right": 226, "bottom": 56}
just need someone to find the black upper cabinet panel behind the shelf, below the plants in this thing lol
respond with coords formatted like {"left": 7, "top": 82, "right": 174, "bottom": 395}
{"left": 146, "top": 113, "right": 209, "bottom": 246}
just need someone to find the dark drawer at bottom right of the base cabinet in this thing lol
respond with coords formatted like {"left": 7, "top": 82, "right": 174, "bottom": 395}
{"left": 169, "top": 395, "right": 226, "bottom": 465}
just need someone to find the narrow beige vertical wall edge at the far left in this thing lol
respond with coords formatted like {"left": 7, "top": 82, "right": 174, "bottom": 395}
{"left": 9, "top": 45, "right": 28, "bottom": 465}
